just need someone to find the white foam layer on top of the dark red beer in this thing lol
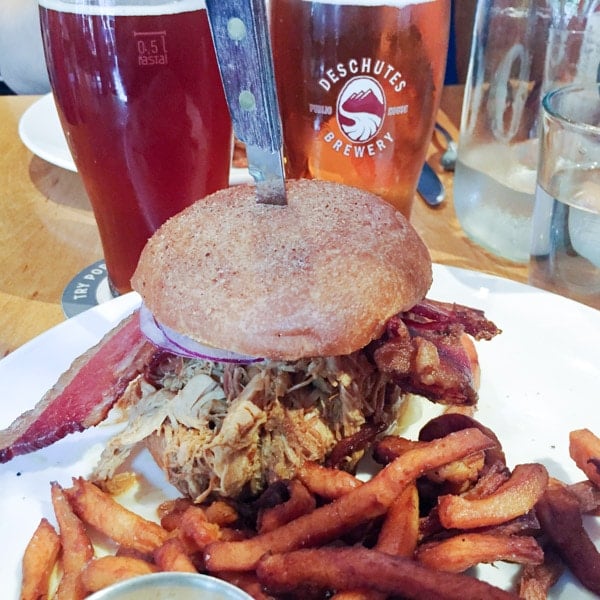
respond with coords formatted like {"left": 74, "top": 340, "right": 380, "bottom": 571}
{"left": 38, "top": 0, "right": 206, "bottom": 17}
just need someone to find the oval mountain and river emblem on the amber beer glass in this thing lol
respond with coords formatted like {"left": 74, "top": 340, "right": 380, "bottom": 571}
{"left": 337, "top": 77, "right": 385, "bottom": 142}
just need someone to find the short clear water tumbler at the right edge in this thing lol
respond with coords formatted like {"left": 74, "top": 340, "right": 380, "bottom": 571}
{"left": 529, "top": 84, "right": 600, "bottom": 309}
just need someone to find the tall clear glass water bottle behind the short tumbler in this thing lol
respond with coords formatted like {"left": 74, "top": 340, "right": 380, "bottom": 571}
{"left": 454, "top": 0, "right": 600, "bottom": 263}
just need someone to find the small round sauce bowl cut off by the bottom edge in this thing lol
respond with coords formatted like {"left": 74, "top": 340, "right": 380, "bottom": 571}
{"left": 87, "top": 572, "right": 252, "bottom": 600}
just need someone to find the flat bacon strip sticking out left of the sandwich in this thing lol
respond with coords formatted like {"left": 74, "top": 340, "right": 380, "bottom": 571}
{"left": 0, "top": 311, "right": 156, "bottom": 463}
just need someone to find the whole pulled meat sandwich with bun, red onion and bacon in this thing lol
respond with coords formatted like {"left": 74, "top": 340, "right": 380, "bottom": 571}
{"left": 0, "top": 180, "right": 498, "bottom": 500}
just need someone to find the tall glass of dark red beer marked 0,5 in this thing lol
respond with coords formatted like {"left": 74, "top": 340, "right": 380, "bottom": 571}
{"left": 39, "top": 0, "right": 232, "bottom": 293}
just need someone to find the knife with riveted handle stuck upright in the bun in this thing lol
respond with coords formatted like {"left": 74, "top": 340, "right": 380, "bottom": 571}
{"left": 206, "top": 0, "right": 286, "bottom": 205}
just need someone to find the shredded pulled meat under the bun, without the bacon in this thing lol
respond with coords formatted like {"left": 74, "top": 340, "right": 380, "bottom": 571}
{"left": 95, "top": 351, "right": 401, "bottom": 501}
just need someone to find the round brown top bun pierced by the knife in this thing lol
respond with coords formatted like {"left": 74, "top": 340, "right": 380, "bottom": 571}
{"left": 132, "top": 180, "right": 431, "bottom": 360}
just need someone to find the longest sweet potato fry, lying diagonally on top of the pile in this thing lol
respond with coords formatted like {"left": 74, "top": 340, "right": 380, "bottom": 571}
{"left": 204, "top": 429, "right": 492, "bottom": 571}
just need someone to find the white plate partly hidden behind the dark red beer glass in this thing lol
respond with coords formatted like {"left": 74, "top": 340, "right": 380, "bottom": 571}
{"left": 19, "top": 94, "right": 252, "bottom": 185}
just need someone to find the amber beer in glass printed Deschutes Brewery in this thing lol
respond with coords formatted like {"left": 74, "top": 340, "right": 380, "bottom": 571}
{"left": 270, "top": 0, "right": 450, "bottom": 216}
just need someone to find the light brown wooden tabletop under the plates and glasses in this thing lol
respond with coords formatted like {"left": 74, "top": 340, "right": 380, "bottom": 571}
{"left": 0, "top": 87, "right": 527, "bottom": 357}
